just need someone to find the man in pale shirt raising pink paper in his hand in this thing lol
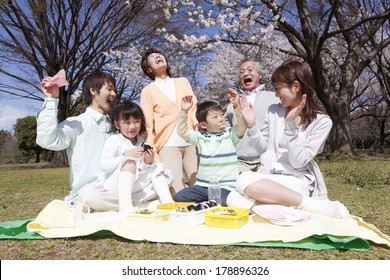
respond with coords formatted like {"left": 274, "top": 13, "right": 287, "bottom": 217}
{"left": 36, "top": 71, "right": 117, "bottom": 211}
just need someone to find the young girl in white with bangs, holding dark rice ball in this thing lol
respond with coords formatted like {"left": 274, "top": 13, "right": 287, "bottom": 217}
{"left": 96, "top": 101, "right": 173, "bottom": 213}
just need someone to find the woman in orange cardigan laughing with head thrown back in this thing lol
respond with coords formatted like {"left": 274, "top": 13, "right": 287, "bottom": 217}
{"left": 140, "top": 48, "right": 198, "bottom": 195}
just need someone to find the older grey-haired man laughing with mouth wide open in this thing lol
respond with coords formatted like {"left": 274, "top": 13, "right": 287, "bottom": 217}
{"left": 225, "top": 58, "right": 279, "bottom": 173}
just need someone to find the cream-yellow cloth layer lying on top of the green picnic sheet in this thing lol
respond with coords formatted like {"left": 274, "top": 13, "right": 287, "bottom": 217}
{"left": 27, "top": 201, "right": 390, "bottom": 248}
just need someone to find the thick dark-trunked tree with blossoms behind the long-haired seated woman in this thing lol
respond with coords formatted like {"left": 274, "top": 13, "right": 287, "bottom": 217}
{"left": 142, "top": 0, "right": 390, "bottom": 154}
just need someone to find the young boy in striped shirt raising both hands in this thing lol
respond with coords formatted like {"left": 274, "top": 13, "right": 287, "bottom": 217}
{"left": 174, "top": 96, "right": 247, "bottom": 206}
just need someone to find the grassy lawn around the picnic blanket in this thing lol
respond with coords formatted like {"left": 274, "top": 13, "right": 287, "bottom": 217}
{"left": 0, "top": 156, "right": 390, "bottom": 260}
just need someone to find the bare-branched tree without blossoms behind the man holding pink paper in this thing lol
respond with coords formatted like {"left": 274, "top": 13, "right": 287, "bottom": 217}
{"left": 0, "top": 0, "right": 165, "bottom": 121}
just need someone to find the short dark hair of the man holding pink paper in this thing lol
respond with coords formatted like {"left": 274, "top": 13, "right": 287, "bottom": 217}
{"left": 83, "top": 71, "right": 116, "bottom": 105}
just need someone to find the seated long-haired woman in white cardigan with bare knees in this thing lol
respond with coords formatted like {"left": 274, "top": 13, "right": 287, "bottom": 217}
{"left": 227, "top": 61, "right": 349, "bottom": 218}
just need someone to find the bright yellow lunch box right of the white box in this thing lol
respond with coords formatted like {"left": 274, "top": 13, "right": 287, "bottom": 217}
{"left": 205, "top": 207, "right": 249, "bottom": 228}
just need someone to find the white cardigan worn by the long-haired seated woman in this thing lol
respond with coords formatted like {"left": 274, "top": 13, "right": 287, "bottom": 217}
{"left": 248, "top": 104, "right": 332, "bottom": 199}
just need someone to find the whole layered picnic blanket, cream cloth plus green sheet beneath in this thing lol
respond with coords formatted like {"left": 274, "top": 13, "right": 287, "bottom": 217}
{"left": 0, "top": 200, "right": 390, "bottom": 250}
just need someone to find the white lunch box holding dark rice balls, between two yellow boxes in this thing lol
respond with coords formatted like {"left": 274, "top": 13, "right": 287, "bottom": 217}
{"left": 169, "top": 201, "right": 217, "bottom": 225}
